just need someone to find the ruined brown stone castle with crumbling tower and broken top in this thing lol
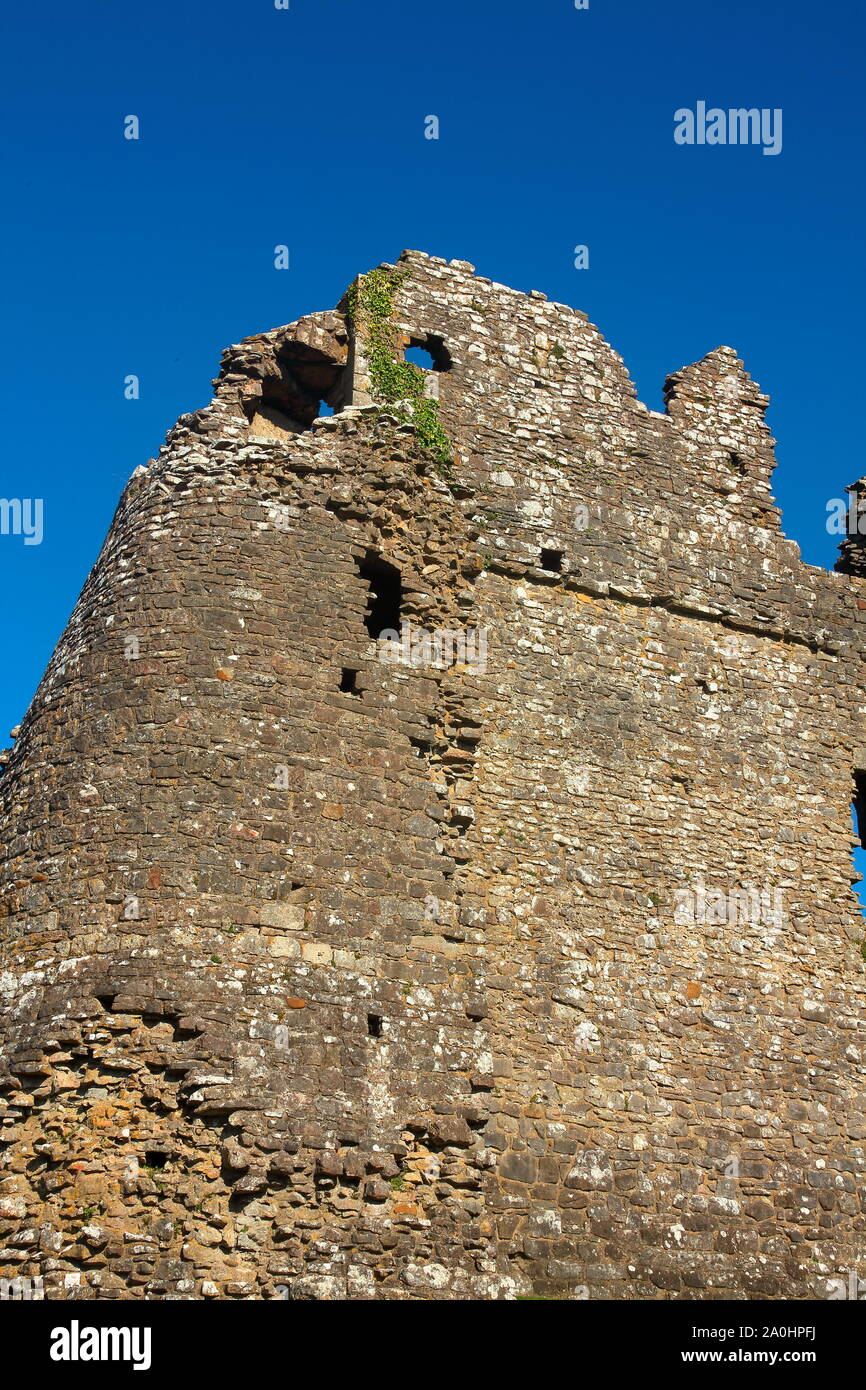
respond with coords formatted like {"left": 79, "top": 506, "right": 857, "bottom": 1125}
{"left": 0, "top": 252, "right": 866, "bottom": 1300}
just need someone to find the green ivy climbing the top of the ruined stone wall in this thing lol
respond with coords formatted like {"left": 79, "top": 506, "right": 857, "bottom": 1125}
{"left": 348, "top": 265, "right": 452, "bottom": 470}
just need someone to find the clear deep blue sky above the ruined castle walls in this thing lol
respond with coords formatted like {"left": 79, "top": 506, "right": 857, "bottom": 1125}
{"left": 0, "top": 0, "right": 866, "bottom": 746}
